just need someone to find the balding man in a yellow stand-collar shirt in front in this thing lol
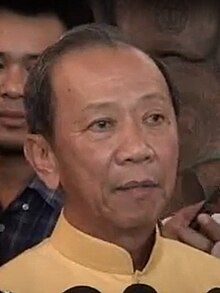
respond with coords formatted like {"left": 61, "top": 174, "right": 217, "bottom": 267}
{"left": 0, "top": 25, "right": 220, "bottom": 293}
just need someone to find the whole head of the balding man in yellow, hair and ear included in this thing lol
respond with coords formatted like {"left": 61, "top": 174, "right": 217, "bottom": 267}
{"left": 25, "top": 25, "right": 178, "bottom": 228}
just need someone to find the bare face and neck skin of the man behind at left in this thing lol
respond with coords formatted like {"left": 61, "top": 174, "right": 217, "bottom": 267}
{"left": 0, "top": 10, "right": 64, "bottom": 208}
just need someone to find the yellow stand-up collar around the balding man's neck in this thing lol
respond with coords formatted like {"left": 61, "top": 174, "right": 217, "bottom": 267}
{"left": 49, "top": 213, "right": 162, "bottom": 275}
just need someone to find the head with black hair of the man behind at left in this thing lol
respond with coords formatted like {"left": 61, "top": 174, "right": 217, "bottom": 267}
{"left": 0, "top": 0, "right": 92, "bottom": 152}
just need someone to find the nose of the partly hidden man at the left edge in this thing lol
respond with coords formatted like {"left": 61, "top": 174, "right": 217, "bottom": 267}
{"left": 1, "top": 65, "right": 27, "bottom": 99}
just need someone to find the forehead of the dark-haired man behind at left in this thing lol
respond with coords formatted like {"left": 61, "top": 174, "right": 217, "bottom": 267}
{"left": 0, "top": 10, "right": 64, "bottom": 55}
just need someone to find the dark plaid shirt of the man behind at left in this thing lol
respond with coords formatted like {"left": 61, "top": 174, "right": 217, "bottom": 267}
{"left": 0, "top": 177, "right": 63, "bottom": 265}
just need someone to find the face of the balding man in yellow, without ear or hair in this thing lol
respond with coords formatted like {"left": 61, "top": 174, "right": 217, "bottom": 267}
{"left": 52, "top": 48, "right": 178, "bottom": 228}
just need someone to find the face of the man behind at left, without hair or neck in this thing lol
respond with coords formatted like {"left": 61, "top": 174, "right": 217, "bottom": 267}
{"left": 0, "top": 11, "right": 64, "bottom": 150}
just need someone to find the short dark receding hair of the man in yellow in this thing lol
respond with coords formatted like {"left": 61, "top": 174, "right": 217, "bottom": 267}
{"left": 24, "top": 24, "right": 178, "bottom": 139}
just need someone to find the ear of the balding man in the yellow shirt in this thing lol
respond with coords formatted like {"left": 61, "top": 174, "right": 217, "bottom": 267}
{"left": 24, "top": 134, "right": 59, "bottom": 189}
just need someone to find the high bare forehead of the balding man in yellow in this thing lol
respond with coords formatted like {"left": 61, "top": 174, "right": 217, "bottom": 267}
{"left": 51, "top": 47, "right": 169, "bottom": 107}
